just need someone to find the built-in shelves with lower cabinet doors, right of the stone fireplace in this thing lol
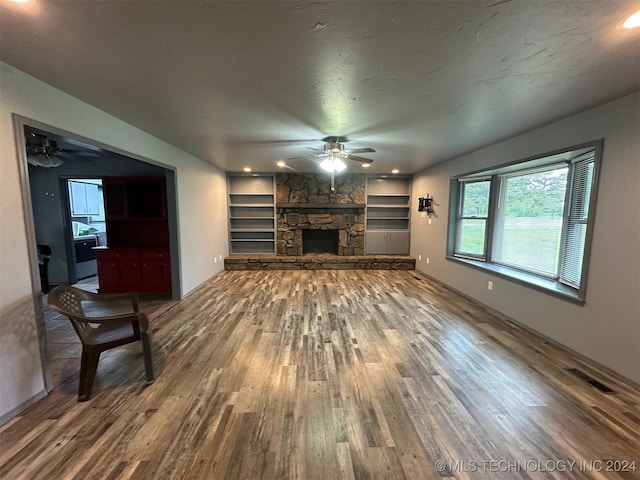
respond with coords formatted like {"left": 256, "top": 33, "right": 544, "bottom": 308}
{"left": 365, "top": 175, "right": 411, "bottom": 255}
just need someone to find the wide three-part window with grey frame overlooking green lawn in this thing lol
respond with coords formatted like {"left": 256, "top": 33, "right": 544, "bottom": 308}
{"left": 447, "top": 142, "right": 602, "bottom": 301}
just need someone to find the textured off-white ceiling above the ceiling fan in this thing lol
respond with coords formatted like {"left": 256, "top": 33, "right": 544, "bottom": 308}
{"left": 0, "top": 0, "right": 640, "bottom": 173}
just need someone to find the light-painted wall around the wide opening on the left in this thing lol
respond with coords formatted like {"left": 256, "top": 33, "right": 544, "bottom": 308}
{"left": 0, "top": 62, "right": 228, "bottom": 419}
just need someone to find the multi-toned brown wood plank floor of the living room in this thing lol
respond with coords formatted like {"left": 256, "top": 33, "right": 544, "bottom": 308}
{"left": 0, "top": 270, "right": 640, "bottom": 480}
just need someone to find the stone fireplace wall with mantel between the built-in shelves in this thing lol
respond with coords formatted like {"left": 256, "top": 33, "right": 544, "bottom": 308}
{"left": 276, "top": 173, "right": 365, "bottom": 255}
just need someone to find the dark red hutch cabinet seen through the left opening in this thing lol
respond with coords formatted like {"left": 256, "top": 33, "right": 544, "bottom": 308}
{"left": 95, "top": 177, "right": 171, "bottom": 293}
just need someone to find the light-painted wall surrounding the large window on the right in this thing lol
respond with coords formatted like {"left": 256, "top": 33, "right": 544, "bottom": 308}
{"left": 411, "top": 93, "right": 640, "bottom": 383}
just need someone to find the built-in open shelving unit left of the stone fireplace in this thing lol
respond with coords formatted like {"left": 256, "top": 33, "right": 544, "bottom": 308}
{"left": 227, "top": 174, "right": 276, "bottom": 254}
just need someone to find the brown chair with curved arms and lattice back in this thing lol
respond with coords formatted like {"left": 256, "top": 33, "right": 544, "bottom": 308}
{"left": 48, "top": 285, "right": 154, "bottom": 402}
